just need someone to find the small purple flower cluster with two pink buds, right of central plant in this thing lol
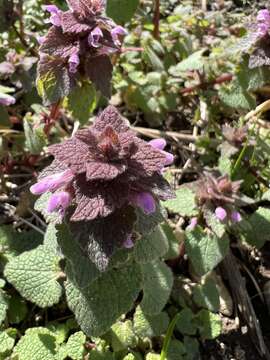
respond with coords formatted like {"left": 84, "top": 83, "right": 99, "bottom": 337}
{"left": 197, "top": 174, "right": 242, "bottom": 223}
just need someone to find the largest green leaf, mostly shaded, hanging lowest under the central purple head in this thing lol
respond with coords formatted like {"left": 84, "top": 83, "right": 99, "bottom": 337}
{"left": 65, "top": 264, "right": 142, "bottom": 336}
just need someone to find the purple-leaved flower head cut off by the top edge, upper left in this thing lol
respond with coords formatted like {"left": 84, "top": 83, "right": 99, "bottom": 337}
{"left": 38, "top": 0, "right": 127, "bottom": 103}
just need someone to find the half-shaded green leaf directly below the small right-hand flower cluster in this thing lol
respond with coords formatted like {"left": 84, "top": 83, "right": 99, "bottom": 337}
{"left": 185, "top": 226, "right": 229, "bottom": 275}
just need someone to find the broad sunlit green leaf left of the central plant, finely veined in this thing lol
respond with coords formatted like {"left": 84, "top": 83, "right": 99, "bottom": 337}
{"left": 5, "top": 245, "right": 62, "bottom": 307}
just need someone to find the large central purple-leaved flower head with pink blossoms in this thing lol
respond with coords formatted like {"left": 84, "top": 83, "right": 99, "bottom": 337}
{"left": 31, "top": 106, "right": 174, "bottom": 269}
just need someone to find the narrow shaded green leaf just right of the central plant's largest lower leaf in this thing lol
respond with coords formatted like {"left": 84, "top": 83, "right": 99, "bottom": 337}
{"left": 141, "top": 261, "right": 173, "bottom": 315}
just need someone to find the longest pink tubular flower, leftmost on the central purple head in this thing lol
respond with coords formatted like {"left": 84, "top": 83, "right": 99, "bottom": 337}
{"left": 30, "top": 169, "right": 74, "bottom": 195}
